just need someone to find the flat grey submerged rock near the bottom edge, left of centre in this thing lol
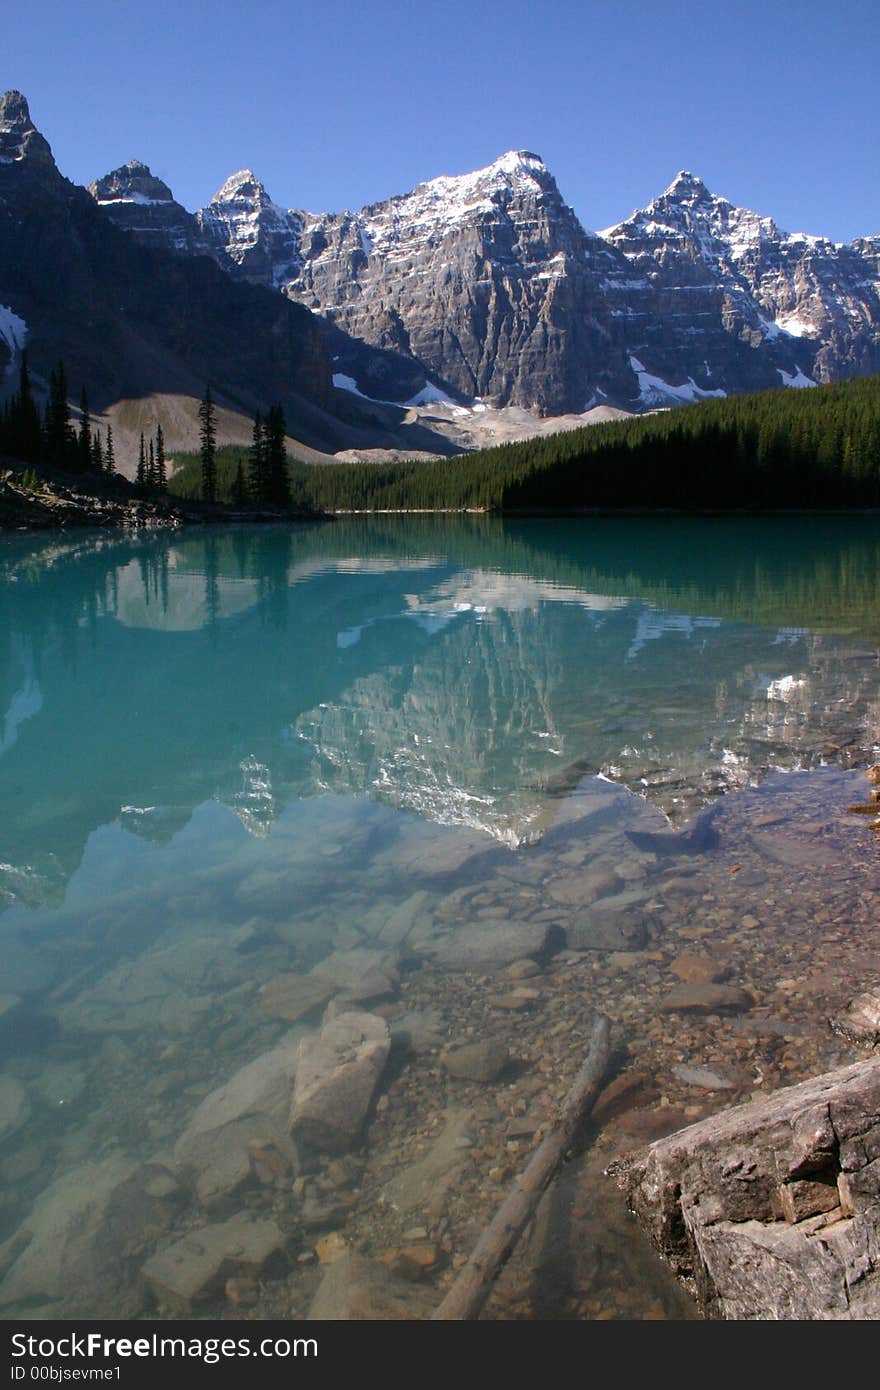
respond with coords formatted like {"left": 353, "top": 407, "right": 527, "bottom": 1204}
{"left": 142, "top": 1212, "right": 285, "bottom": 1316}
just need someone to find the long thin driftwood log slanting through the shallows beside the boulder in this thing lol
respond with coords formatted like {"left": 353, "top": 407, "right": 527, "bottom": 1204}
{"left": 432, "top": 1013, "right": 610, "bottom": 1322}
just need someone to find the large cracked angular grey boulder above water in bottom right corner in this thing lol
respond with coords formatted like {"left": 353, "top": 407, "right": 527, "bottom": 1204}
{"left": 609, "top": 1056, "right": 880, "bottom": 1321}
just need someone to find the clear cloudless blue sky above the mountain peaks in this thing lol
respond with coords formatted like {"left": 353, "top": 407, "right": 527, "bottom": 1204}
{"left": 0, "top": 0, "right": 880, "bottom": 240}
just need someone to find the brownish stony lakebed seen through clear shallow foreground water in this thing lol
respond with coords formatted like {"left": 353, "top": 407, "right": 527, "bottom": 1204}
{"left": 0, "top": 767, "right": 880, "bottom": 1319}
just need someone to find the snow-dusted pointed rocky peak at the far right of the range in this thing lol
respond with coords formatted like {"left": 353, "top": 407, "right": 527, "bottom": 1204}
{"left": 605, "top": 172, "right": 880, "bottom": 398}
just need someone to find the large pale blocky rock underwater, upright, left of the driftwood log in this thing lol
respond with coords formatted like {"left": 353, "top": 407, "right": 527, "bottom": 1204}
{"left": 291, "top": 1013, "right": 391, "bottom": 1155}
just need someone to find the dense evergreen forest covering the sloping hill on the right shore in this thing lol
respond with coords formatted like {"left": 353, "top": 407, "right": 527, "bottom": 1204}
{"left": 170, "top": 377, "right": 880, "bottom": 512}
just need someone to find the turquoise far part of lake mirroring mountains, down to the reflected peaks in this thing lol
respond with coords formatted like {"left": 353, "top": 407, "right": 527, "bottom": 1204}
{"left": 0, "top": 518, "right": 880, "bottom": 902}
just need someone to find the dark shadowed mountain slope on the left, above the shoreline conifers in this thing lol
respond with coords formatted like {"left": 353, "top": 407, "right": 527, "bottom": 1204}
{"left": 0, "top": 92, "right": 334, "bottom": 439}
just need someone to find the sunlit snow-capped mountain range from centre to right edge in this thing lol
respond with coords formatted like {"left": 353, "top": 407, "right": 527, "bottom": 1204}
{"left": 93, "top": 152, "right": 880, "bottom": 414}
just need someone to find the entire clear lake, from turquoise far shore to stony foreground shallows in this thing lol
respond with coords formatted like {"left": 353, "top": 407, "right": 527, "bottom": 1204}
{"left": 0, "top": 518, "right": 880, "bottom": 1318}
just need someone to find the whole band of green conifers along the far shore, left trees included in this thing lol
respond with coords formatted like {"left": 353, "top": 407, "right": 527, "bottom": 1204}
{"left": 6, "top": 359, "right": 880, "bottom": 512}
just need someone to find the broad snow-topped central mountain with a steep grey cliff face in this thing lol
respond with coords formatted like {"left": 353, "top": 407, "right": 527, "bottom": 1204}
{"left": 288, "top": 152, "right": 639, "bottom": 414}
